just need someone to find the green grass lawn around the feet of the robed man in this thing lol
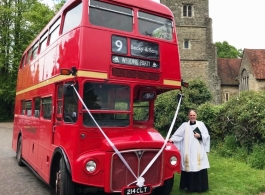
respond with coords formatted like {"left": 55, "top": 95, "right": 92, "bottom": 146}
{"left": 171, "top": 153, "right": 265, "bottom": 195}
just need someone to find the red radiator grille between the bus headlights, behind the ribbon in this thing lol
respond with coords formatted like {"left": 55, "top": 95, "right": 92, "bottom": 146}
{"left": 110, "top": 150, "right": 163, "bottom": 192}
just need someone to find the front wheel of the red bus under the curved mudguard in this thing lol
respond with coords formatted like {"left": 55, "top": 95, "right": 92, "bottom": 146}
{"left": 56, "top": 158, "right": 75, "bottom": 195}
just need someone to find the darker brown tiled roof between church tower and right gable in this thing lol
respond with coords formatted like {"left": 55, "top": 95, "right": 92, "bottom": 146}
{"left": 217, "top": 58, "right": 241, "bottom": 85}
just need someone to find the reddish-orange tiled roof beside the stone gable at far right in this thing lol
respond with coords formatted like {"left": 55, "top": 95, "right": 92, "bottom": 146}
{"left": 244, "top": 49, "right": 265, "bottom": 79}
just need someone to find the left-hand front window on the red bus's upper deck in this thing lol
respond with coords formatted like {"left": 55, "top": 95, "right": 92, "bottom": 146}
{"left": 89, "top": 0, "right": 133, "bottom": 32}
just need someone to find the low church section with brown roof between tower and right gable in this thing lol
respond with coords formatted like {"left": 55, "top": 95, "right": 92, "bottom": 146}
{"left": 217, "top": 58, "right": 241, "bottom": 103}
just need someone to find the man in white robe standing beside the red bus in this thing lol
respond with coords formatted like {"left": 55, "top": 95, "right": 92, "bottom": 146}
{"left": 169, "top": 110, "right": 210, "bottom": 192}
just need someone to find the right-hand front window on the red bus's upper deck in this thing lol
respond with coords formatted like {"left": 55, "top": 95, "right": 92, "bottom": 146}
{"left": 138, "top": 12, "right": 173, "bottom": 41}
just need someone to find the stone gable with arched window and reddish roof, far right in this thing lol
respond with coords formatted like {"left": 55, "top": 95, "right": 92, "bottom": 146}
{"left": 238, "top": 49, "right": 265, "bottom": 92}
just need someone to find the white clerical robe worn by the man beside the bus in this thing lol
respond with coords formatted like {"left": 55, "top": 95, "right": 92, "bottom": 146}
{"left": 170, "top": 121, "right": 210, "bottom": 172}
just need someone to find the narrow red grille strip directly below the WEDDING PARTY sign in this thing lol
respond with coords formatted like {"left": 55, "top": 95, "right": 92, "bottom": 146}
{"left": 112, "top": 68, "right": 160, "bottom": 81}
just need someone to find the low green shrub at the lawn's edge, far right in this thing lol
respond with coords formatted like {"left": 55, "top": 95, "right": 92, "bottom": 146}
{"left": 248, "top": 144, "right": 265, "bottom": 169}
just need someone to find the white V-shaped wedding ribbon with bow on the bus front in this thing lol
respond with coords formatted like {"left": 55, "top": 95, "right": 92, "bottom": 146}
{"left": 71, "top": 84, "right": 182, "bottom": 187}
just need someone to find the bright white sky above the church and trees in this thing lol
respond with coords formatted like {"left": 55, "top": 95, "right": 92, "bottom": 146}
{"left": 40, "top": 0, "right": 265, "bottom": 49}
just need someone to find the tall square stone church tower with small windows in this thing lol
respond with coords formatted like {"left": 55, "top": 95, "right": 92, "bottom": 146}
{"left": 161, "top": 0, "right": 221, "bottom": 104}
